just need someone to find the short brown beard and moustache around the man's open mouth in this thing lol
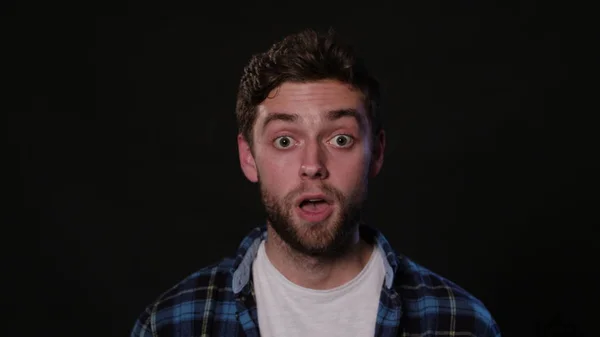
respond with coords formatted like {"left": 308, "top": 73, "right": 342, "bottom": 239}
{"left": 259, "top": 180, "right": 366, "bottom": 258}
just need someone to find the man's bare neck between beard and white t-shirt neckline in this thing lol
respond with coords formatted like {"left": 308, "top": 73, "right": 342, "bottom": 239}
{"left": 265, "top": 226, "right": 373, "bottom": 290}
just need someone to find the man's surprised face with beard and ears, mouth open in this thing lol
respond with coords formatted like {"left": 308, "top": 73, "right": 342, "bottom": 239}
{"left": 238, "top": 81, "right": 384, "bottom": 256}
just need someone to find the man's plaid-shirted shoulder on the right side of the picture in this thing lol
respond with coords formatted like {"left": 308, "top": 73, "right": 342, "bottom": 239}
{"left": 394, "top": 256, "right": 500, "bottom": 337}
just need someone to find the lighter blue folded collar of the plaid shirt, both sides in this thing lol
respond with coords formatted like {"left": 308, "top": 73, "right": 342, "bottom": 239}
{"left": 231, "top": 224, "right": 399, "bottom": 294}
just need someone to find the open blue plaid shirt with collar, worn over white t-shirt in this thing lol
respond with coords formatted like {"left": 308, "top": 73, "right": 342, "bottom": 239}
{"left": 131, "top": 225, "right": 500, "bottom": 337}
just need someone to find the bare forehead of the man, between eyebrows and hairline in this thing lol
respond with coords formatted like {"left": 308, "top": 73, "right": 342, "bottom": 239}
{"left": 257, "top": 80, "right": 366, "bottom": 119}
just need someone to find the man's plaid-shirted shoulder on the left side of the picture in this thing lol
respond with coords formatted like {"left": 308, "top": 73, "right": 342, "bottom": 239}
{"left": 131, "top": 258, "right": 235, "bottom": 337}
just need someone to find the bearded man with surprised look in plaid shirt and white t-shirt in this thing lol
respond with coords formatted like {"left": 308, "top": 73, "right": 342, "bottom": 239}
{"left": 132, "top": 30, "right": 500, "bottom": 337}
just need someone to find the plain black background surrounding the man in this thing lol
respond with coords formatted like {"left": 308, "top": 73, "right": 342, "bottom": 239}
{"left": 2, "top": 1, "right": 598, "bottom": 336}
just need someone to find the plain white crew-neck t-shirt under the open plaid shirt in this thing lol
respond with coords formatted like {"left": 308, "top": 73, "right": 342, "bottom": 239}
{"left": 252, "top": 241, "right": 385, "bottom": 337}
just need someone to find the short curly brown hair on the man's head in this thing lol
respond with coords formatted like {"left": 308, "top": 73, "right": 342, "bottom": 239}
{"left": 236, "top": 29, "right": 381, "bottom": 147}
